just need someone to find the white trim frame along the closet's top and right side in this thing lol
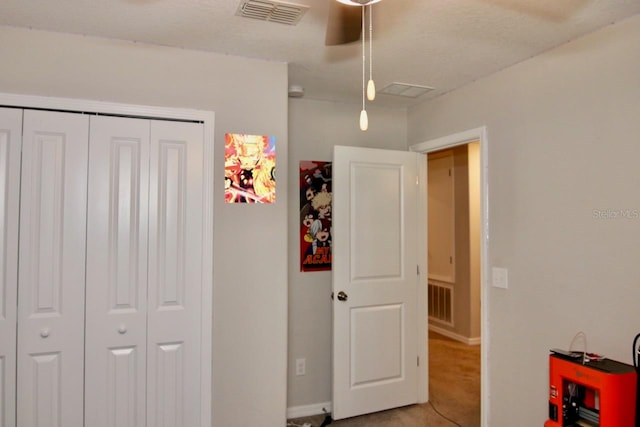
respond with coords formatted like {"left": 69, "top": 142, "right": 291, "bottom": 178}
{"left": 0, "top": 93, "right": 215, "bottom": 427}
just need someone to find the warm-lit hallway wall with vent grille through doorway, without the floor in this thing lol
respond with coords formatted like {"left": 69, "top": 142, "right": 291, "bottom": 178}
{"left": 427, "top": 141, "right": 481, "bottom": 345}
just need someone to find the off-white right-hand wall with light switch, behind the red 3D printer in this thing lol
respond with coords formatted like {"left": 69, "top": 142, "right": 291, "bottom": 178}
{"left": 408, "top": 16, "right": 640, "bottom": 426}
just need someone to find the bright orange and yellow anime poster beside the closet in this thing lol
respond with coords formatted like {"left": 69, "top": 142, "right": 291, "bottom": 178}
{"left": 224, "top": 133, "right": 276, "bottom": 203}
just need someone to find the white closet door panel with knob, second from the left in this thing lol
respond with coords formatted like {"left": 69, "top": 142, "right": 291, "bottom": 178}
{"left": 17, "top": 110, "right": 88, "bottom": 427}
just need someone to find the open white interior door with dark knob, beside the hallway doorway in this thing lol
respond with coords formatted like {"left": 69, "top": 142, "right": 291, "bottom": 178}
{"left": 332, "top": 147, "right": 420, "bottom": 419}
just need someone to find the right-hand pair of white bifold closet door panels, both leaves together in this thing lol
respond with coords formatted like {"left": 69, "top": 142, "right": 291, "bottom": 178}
{"left": 85, "top": 116, "right": 203, "bottom": 427}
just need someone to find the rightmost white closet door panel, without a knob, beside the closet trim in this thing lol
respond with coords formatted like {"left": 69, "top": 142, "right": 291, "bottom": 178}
{"left": 147, "top": 121, "right": 203, "bottom": 427}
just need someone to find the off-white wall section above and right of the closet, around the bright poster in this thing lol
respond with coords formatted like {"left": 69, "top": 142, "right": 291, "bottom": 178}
{"left": 0, "top": 27, "right": 288, "bottom": 427}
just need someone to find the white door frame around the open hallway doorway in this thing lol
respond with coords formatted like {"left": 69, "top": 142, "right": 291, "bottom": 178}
{"left": 409, "top": 126, "right": 490, "bottom": 427}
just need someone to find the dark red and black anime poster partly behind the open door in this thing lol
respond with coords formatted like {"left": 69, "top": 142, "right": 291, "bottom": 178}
{"left": 300, "top": 161, "right": 332, "bottom": 271}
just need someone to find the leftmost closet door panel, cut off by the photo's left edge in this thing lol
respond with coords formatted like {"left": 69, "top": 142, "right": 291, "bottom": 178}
{"left": 0, "top": 108, "right": 22, "bottom": 427}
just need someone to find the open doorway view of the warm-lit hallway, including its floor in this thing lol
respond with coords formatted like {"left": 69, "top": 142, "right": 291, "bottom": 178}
{"left": 425, "top": 141, "right": 481, "bottom": 425}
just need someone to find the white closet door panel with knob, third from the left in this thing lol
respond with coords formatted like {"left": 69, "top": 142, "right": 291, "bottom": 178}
{"left": 85, "top": 116, "right": 149, "bottom": 427}
